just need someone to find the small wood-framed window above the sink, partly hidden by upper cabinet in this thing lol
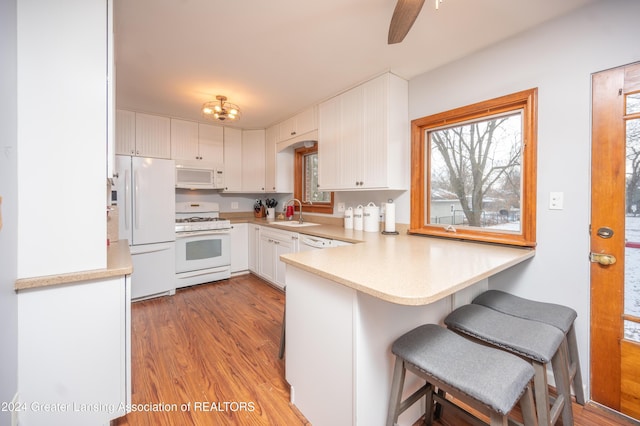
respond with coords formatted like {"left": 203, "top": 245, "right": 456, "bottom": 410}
{"left": 293, "top": 144, "right": 333, "bottom": 214}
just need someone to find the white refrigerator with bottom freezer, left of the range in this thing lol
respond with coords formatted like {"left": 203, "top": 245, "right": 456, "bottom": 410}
{"left": 114, "top": 155, "right": 175, "bottom": 299}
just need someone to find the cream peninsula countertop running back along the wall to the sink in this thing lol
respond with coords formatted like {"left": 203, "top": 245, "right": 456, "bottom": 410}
{"left": 251, "top": 219, "right": 535, "bottom": 306}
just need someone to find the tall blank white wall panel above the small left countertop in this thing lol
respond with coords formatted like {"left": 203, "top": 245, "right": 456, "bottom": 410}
{"left": 17, "top": 0, "right": 107, "bottom": 278}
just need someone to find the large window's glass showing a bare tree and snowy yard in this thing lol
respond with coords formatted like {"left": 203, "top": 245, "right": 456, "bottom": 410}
{"left": 426, "top": 112, "right": 522, "bottom": 232}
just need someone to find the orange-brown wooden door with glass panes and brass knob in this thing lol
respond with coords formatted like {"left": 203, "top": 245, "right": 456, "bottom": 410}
{"left": 590, "top": 64, "right": 640, "bottom": 418}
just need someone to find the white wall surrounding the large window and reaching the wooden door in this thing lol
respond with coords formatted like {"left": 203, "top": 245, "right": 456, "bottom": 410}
{"left": 409, "top": 0, "right": 640, "bottom": 400}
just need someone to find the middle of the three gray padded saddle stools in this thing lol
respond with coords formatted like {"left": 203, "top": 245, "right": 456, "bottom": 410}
{"left": 444, "top": 304, "right": 573, "bottom": 426}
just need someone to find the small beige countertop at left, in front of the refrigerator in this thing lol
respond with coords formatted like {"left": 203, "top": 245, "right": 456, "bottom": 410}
{"left": 15, "top": 240, "right": 133, "bottom": 291}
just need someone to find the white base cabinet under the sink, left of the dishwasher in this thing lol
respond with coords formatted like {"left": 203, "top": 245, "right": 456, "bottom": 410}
{"left": 259, "top": 227, "right": 299, "bottom": 288}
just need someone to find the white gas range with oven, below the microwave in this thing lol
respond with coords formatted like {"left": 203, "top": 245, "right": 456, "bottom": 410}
{"left": 175, "top": 202, "right": 231, "bottom": 288}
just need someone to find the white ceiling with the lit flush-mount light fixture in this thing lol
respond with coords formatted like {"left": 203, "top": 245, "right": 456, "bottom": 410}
{"left": 114, "top": 0, "right": 596, "bottom": 129}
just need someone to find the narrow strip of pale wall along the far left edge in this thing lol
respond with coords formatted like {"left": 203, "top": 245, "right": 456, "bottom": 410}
{"left": 0, "top": 0, "right": 18, "bottom": 425}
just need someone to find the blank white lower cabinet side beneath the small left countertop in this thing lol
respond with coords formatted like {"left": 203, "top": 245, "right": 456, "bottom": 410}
{"left": 18, "top": 275, "right": 131, "bottom": 426}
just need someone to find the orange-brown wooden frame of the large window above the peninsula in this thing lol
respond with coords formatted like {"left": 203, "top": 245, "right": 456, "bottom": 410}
{"left": 409, "top": 88, "right": 538, "bottom": 247}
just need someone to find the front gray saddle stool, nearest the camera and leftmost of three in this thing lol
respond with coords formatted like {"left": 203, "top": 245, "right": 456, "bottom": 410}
{"left": 387, "top": 324, "right": 537, "bottom": 426}
